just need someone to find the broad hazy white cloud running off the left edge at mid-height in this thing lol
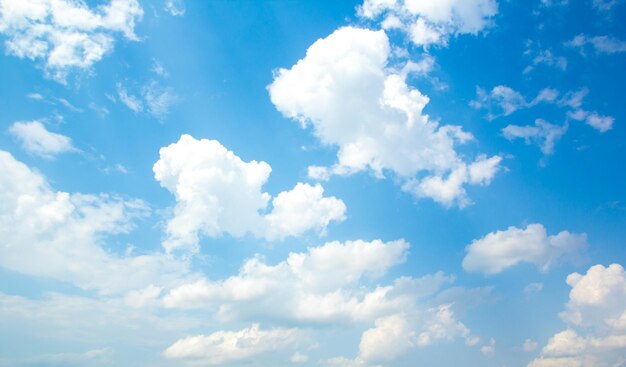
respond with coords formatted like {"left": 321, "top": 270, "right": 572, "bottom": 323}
{"left": 0, "top": 151, "right": 187, "bottom": 294}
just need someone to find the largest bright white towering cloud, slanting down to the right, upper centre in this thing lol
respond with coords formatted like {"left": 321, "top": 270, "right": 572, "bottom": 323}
{"left": 268, "top": 27, "right": 500, "bottom": 205}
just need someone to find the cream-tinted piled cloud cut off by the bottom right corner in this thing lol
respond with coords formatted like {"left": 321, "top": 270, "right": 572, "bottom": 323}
{"left": 529, "top": 264, "right": 626, "bottom": 367}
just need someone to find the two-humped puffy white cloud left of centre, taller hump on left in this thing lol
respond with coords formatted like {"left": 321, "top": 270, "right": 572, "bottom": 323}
{"left": 153, "top": 135, "right": 346, "bottom": 251}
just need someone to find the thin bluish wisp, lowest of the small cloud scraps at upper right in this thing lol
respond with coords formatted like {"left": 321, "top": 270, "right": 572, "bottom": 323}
{"left": 502, "top": 119, "right": 568, "bottom": 155}
